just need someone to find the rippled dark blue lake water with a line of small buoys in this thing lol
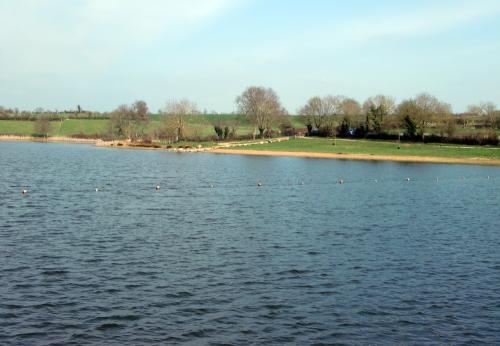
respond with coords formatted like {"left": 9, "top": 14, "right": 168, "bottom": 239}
{"left": 0, "top": 142, "right": 500, "bottom": 345}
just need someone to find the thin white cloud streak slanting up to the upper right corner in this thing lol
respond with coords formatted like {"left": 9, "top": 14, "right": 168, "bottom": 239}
{"left": 253, "top": 1, "right": 500, "bottom": 63}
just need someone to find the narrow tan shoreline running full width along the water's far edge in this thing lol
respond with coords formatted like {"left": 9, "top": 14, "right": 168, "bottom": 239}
{"left": 0, "top": 135, "right": 500, "bottom": 166}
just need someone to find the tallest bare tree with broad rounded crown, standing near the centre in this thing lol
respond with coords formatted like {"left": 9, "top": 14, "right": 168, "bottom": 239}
{"left": 236, "top": 87, "right": 286, "bottom": 139}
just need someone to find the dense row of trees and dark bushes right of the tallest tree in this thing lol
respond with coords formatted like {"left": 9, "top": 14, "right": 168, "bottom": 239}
{"left": 299, "top": 93, "right": 500, "bottom": 144}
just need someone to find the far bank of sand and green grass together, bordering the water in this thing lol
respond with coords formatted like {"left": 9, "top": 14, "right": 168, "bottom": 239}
{"left": 0, "top": 136, "right": 500, "bottom": 166}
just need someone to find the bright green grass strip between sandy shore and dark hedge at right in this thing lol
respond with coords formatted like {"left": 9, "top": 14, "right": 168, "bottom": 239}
{"left": 237, "top": 138, "right": 500, "bottom": 159}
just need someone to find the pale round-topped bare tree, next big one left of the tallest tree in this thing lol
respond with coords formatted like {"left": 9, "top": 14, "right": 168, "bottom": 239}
{"left": 160, "top": 99, "right": 200, "bottom": 141}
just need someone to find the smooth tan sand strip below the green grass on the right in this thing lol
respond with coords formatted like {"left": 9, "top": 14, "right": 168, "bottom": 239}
{"left": 210, "top": 149, "right": 500, "bottom": 166}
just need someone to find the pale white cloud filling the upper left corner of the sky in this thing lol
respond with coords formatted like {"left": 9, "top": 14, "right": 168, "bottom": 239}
{"left": 0, "top": 0, "right": 238, "bottom": 80}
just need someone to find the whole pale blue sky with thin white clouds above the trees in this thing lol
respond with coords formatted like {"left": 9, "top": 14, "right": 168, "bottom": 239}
{"left": 0, "top": 0, "right": 500, "bottom": 113}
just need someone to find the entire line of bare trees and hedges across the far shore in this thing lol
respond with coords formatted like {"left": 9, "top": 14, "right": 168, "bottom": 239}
{"left": 0, "top": 86, "right": 500, "bottom": 145}
